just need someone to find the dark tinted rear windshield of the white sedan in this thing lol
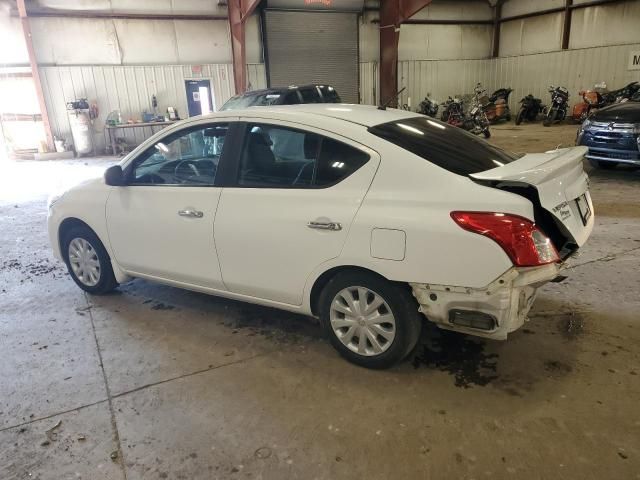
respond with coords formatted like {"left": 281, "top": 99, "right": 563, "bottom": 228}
{"left": 369, "top": 116, "right": 518, "bottom": 175}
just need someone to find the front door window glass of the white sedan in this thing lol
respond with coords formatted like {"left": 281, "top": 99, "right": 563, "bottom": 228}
{"left": 130, "top": 124, "right": 228, "bottom": 186}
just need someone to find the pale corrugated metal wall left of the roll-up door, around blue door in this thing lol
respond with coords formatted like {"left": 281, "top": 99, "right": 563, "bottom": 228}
{"left": 40, "top": 64, "right": 266, "bottom": 153}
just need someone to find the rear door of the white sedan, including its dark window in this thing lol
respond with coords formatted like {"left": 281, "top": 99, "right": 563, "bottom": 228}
{"left": 215, "top": 120, "right": 379, "bottom": 305}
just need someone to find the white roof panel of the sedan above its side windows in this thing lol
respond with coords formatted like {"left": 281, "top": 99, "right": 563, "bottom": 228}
{"left": 200, "top": 103, "right": 421, "bottom": 127}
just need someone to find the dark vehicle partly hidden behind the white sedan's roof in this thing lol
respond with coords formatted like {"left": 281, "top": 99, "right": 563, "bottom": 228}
{"left": 220, "top": 85, "right": 342, "bottom": 110}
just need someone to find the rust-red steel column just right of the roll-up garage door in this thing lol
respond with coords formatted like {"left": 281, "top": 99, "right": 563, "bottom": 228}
{"left": 380, "top": 0, "right": 431, "bottom": 106}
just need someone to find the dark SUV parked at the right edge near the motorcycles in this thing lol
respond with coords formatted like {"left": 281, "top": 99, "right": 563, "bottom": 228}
{"left": 576, "top": 101, "right": 640, "bottom": 168}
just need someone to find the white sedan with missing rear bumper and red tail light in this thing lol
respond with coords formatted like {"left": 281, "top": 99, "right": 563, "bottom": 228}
{"left": 48, "top": 104, "right": 594, "bottom": 368}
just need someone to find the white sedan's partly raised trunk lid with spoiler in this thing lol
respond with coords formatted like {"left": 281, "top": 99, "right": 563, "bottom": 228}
{"left": 470, "top": 147, "right": 593, "bottom": 247}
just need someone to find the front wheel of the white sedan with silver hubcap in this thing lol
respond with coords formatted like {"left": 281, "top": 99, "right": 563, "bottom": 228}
{"left": 62, "top": 226, "right": 118, "bottom": 295}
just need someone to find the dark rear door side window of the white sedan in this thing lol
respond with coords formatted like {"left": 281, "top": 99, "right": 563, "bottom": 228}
{"left": 238, "top": 124, "right": 369, "bottom": 188}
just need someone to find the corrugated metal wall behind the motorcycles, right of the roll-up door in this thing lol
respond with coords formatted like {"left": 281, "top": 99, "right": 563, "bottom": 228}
{"left": 360, "top": 43, "right": 640, "bottom": 110}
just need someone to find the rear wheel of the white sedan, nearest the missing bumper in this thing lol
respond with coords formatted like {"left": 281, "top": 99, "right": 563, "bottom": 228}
{"left": 319, "top": 272, "right": 423, "bottom": 369}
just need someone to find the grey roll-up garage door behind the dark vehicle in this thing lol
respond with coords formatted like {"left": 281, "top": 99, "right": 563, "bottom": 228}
{"left": 265, "top": 10, "right": 358, "bottom": 103}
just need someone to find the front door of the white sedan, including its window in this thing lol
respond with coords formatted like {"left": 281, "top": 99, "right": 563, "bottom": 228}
{"left": 106, "top": 123, "right": 228, "bottom": 289}
